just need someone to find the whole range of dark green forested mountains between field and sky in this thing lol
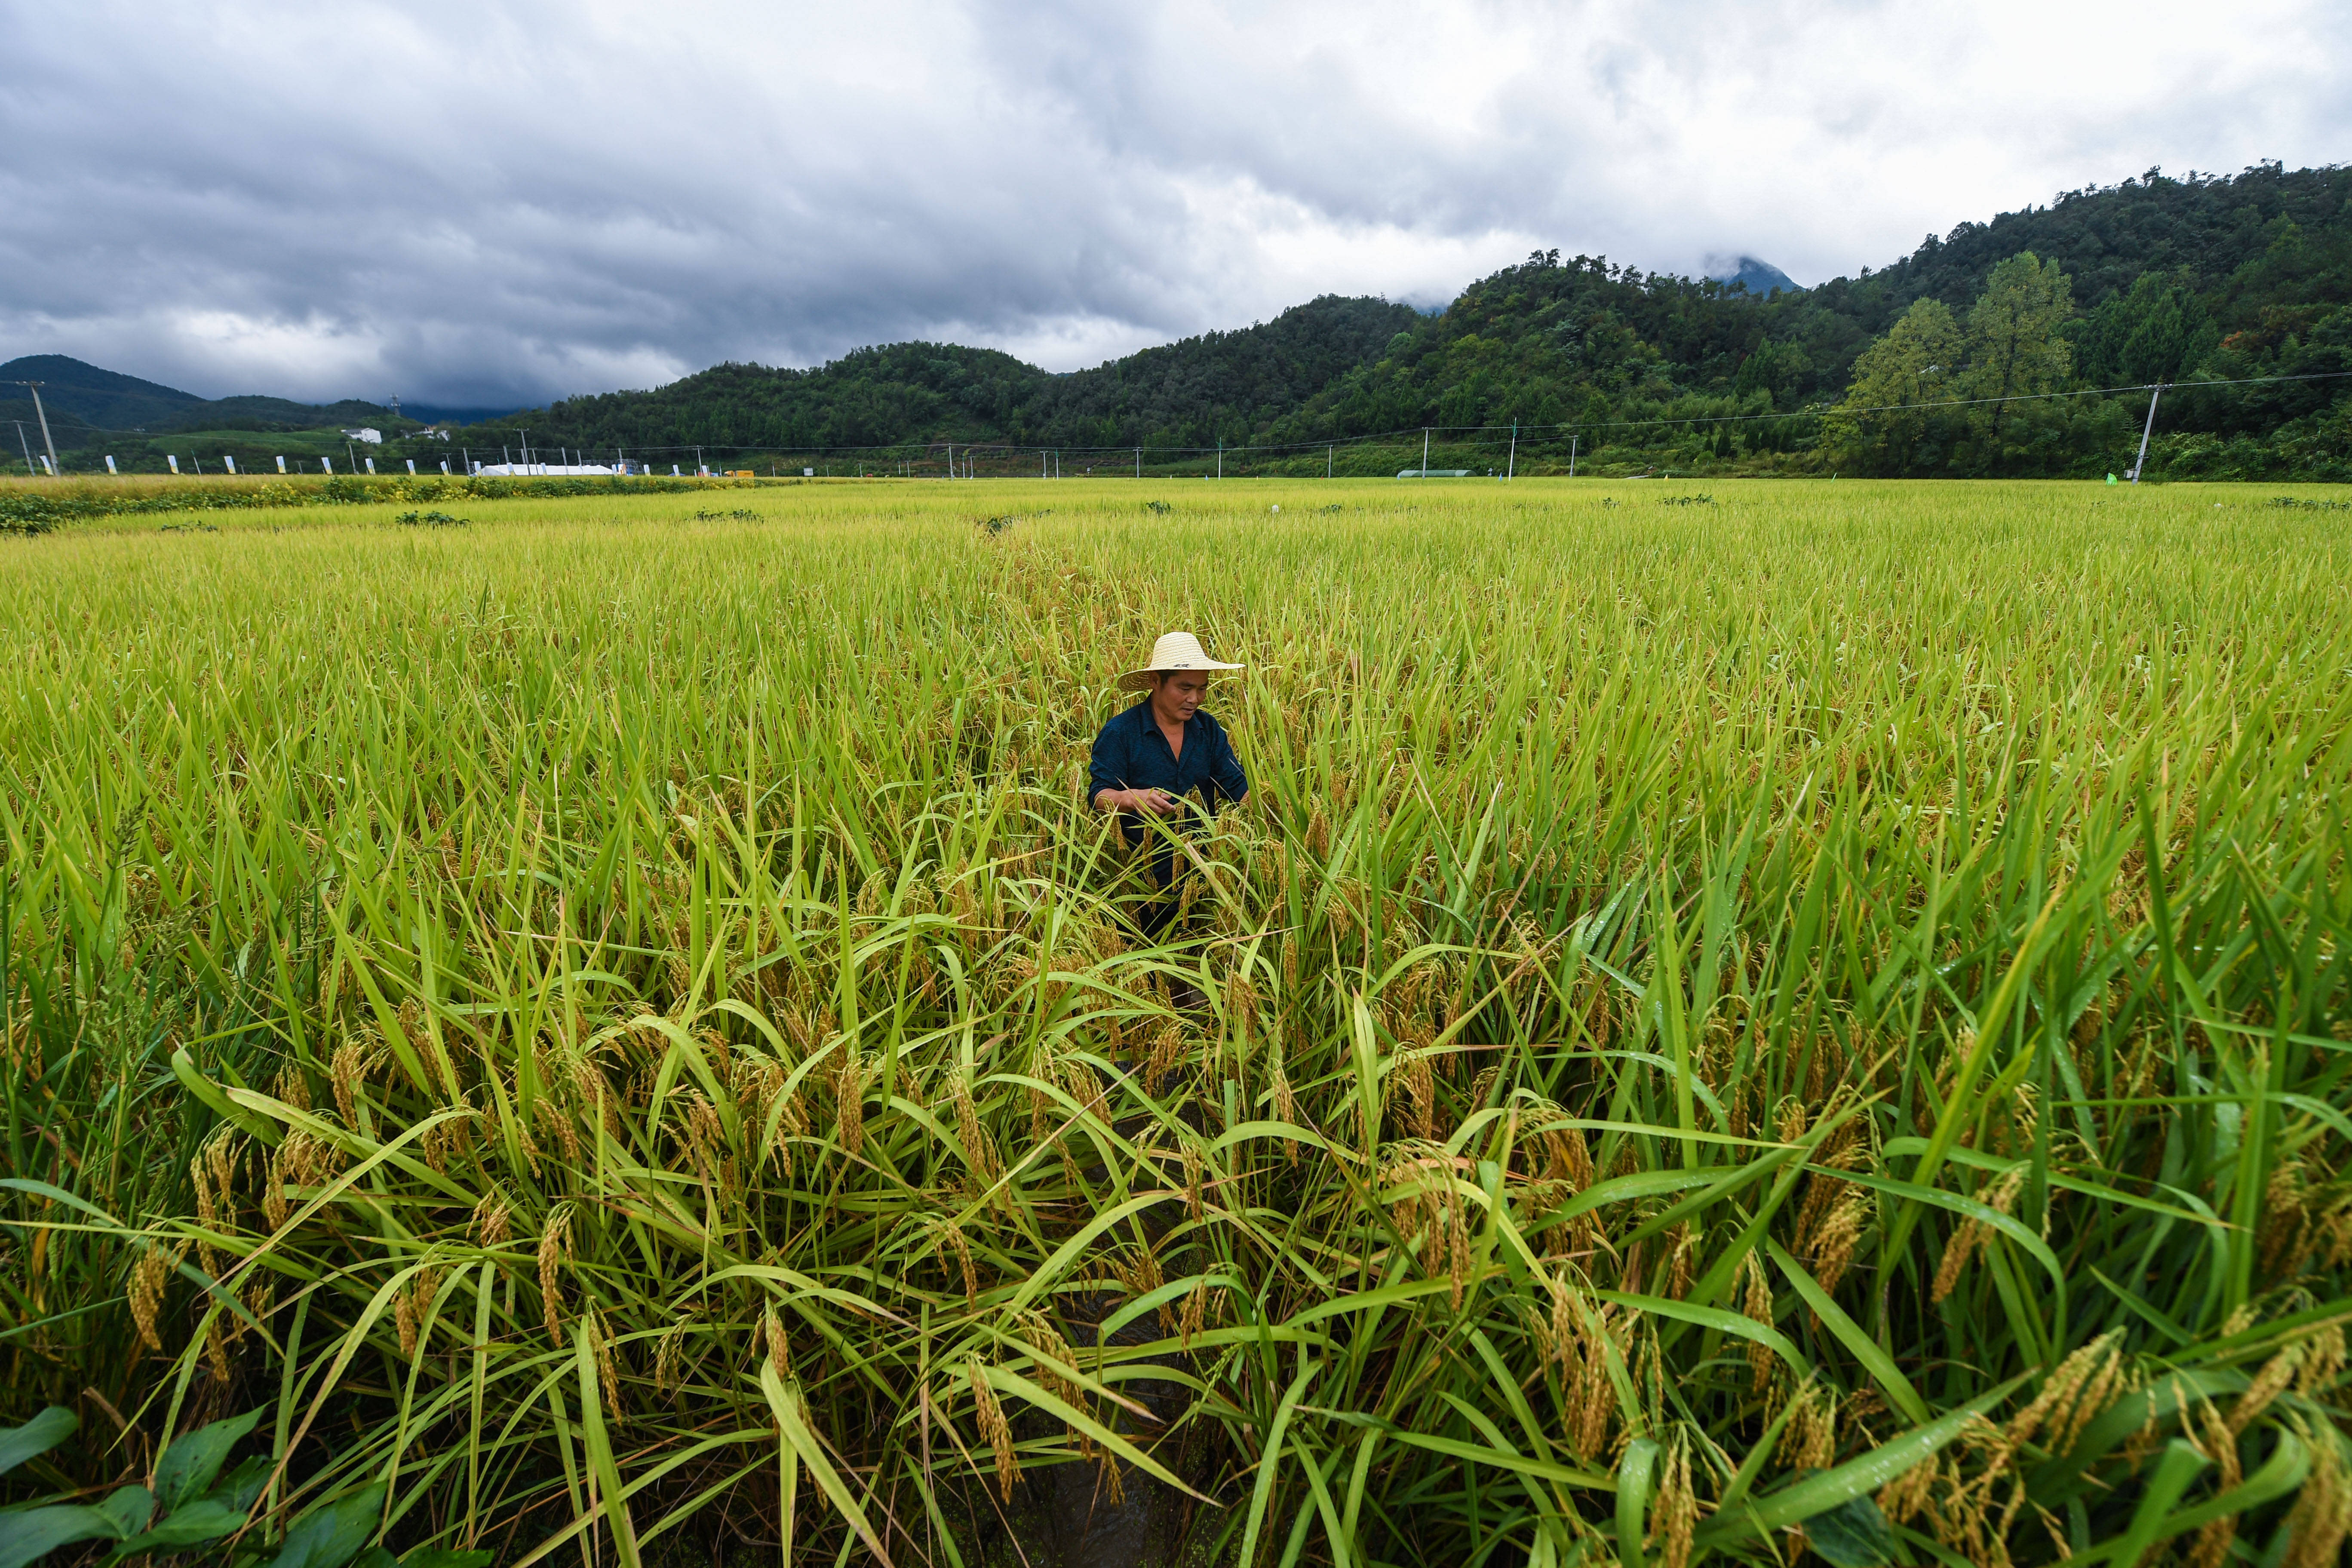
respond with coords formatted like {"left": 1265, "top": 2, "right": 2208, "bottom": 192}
{"left": 23, "top": 165, "right": 2352, "bottom": 479}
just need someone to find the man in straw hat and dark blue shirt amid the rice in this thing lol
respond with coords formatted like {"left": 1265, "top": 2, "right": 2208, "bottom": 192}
{"left": 1089, "top": 632, "right": 1249, "bottom": 940}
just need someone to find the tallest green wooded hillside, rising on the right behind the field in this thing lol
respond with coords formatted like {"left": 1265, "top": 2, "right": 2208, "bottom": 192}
{"left": 1265, "top": 165, "right": 2352, "bottom": 477}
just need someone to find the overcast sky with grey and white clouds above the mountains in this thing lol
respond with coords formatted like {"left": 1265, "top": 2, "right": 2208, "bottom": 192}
{"left": 0, "top": 0, "right": 2352, "bottom": 404}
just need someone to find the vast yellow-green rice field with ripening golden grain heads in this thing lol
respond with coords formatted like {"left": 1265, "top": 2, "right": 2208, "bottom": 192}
{"left": 0, "top": 479, "right": 2352, "bottom": 1568}
